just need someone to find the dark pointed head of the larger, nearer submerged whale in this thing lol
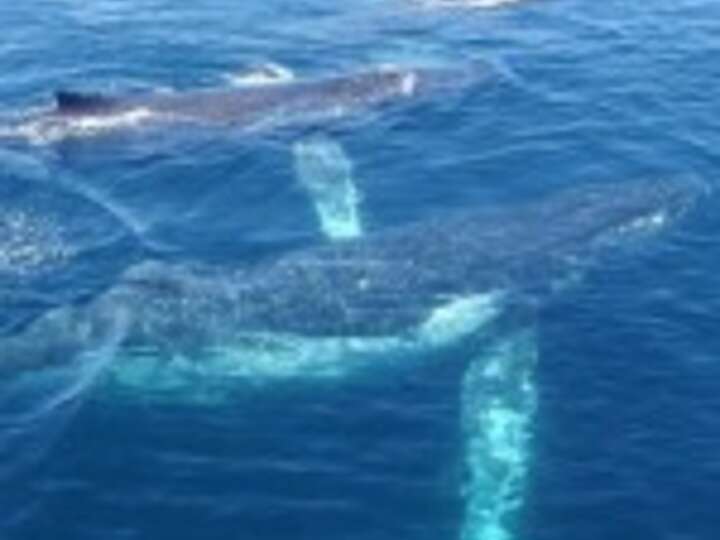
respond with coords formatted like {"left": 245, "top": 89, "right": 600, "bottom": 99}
{"left": 492, "top": 179, "right": 711, "bottom": 296}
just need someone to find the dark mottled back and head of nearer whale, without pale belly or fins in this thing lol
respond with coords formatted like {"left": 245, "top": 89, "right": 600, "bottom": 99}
{"left": 0, "top": 177, "right": 705, "bottom": 380}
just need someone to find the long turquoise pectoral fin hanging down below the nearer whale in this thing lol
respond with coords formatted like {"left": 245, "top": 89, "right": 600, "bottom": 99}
{"left": 460, "top": 329, "right": 538, "bottom": 540}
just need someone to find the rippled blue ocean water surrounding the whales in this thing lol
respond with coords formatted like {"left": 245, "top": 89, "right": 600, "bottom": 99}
{"left": 0, "top": 0, "right": 720, "bottom": 540}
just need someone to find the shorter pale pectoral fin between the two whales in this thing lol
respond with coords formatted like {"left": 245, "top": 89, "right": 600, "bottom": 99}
{"left": 293, "top": 136, "right": 363, "bottom": 240}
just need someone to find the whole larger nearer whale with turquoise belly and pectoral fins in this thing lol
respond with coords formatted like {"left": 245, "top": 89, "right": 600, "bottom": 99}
{"left": 0, "top": 173, "right": 709, "bottom": 540}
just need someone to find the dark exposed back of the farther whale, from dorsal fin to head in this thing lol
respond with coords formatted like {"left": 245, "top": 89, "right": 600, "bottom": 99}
{"left": 47, "top": 65, "right": 491, "bottom": 124}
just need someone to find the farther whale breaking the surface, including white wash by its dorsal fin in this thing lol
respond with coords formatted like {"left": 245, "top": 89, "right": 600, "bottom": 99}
{"left": 2, "top": 63, "right": 484, "bottom": 143}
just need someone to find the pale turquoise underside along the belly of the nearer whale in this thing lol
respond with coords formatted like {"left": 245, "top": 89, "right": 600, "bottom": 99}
{"left": 105, "top": 292, "right": 502, "bottom": 402}
